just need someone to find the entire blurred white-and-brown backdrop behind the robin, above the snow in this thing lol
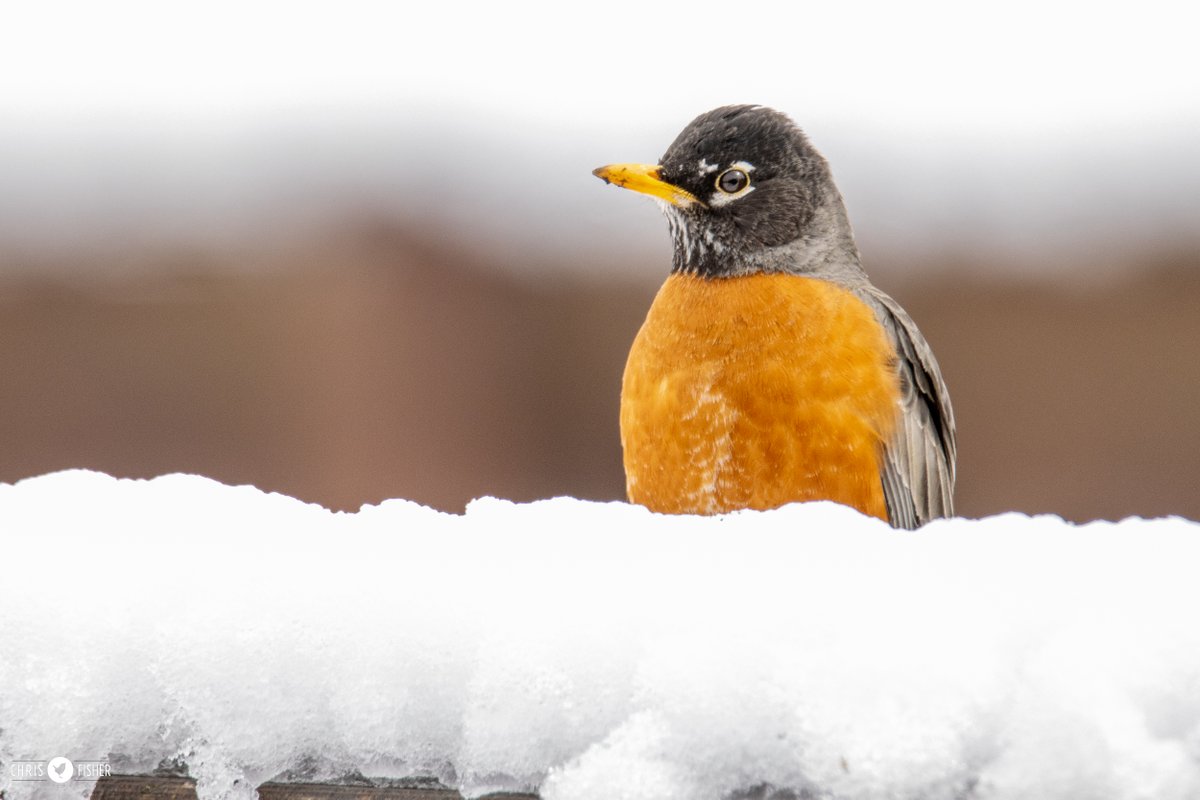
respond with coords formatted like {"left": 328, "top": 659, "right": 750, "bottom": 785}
{"left": 0, "top": 1, "right": 1200, "bottom": 521}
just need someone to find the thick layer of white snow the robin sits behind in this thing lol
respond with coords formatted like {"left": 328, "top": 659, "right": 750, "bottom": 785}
{"left": 0, "top": 471, "right": 1200, "bottom": 800}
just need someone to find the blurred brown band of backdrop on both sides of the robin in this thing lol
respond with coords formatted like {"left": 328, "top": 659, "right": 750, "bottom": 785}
{"left": 0, "top": 219, "right": 1200, "bottom": 519}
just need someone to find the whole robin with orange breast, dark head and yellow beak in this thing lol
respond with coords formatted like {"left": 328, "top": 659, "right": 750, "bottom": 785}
{"left": 595, "top": 106, "right": 955, "bottom": 528}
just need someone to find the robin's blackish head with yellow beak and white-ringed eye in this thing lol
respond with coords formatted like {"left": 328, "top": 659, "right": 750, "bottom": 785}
{"left": 594, "top": 106, "right": 858, "bottom": 278}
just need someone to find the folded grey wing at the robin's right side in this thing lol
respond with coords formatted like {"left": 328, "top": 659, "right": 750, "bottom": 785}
{"left": 860, "top": 285, "right": 958, "bottom": 528}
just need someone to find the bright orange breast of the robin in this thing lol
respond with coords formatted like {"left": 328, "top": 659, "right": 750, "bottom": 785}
{"left": 620, "top": 275, "right": 899, "bottom": 519}
